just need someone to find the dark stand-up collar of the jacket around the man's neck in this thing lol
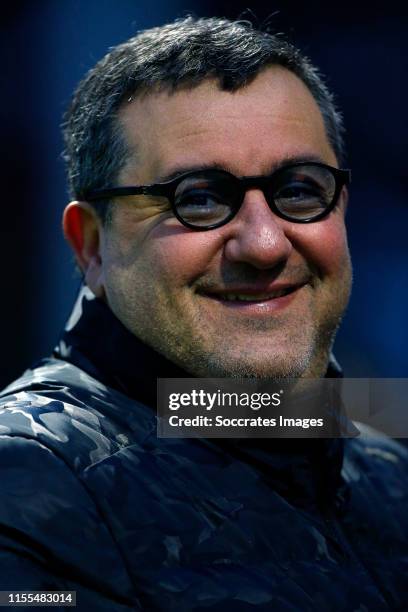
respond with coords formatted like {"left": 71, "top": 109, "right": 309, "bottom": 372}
{"left": 54, "top": 286, "right": 344, "bottom": 509}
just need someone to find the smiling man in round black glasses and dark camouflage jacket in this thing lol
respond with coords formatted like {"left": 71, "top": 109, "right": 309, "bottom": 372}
{"left": 0, "top": 18, "right": 408, "bottom": 612}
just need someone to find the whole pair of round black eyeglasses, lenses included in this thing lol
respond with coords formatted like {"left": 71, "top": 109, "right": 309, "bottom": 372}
{"left": 83, "top": 162, "right": 351, "bottom": 230}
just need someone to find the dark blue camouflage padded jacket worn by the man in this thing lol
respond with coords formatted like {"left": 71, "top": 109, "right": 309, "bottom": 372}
{"left": 0, "top": 290, "right": 408, "bottom": 612}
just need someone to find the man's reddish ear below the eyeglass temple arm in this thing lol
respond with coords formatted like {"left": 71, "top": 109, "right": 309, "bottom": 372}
{"left": 62, "top": 202, "right": 105, "bottom": 298}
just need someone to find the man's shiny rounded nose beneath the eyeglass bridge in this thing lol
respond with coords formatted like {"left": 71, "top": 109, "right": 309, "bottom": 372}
{"left": 225, "top": 189, "right": 293, "bottom": 270}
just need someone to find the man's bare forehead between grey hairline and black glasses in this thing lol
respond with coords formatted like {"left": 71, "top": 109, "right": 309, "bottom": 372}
{"left": 120, "top": 66, "right": 336, "bottom": 183}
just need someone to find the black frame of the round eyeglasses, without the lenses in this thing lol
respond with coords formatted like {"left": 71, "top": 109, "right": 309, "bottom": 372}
{"left": 81, "top": 161, "right": 351, "bottom": 231}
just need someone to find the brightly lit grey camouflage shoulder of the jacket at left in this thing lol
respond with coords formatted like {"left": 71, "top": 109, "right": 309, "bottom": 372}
{"left": 0, "top": 359, "right": 155, "bottom": 474}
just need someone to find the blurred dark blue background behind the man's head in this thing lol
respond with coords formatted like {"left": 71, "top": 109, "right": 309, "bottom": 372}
{"left": 0, "top": 0, "right": 408, "bottom": 386}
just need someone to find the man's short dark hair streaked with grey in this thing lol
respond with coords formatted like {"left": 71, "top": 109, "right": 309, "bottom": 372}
{"left": 63, "top": 17, "right": 344, "bottom": 222}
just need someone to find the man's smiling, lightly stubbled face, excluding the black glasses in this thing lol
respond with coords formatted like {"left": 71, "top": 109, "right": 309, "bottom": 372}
{"left": 95, "top": 67, "right": 351, "bottom": 377}
